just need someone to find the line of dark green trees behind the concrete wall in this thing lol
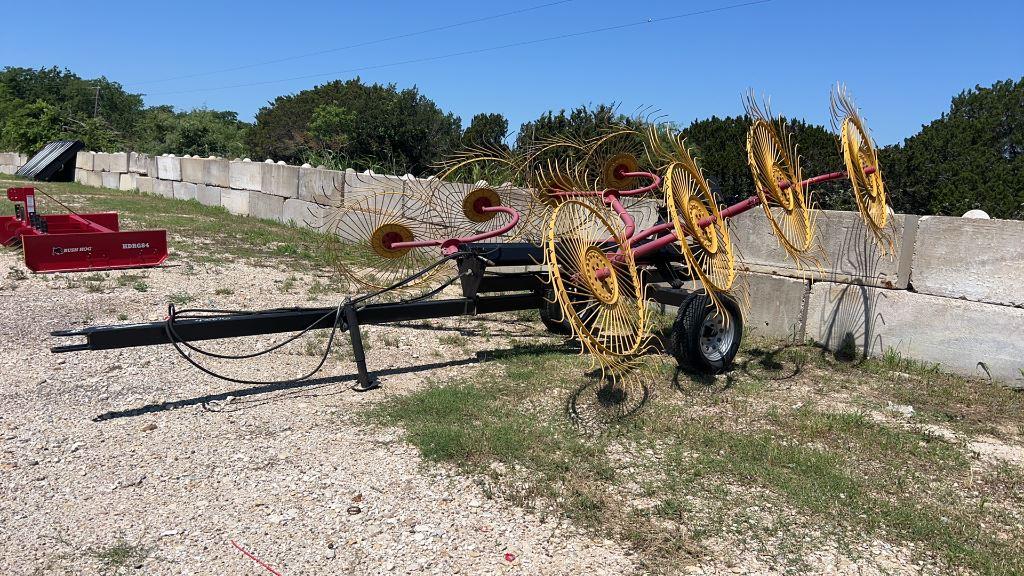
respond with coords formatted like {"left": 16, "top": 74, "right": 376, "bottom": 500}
{"left": 0, "top": 67, "right": 1024, "bottom": 218}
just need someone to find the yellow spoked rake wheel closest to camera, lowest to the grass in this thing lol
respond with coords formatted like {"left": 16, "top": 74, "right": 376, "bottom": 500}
{"left": 545, "top": 200, "right": 649, "bottom": 381}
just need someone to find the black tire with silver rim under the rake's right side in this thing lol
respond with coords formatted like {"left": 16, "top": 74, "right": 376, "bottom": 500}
{"left": 669, "top": 294, "right": 743, "bottom": 374}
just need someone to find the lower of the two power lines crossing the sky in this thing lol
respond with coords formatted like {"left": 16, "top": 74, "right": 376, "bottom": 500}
{"left": 146, "top": 0, "right": 772, "bottom": 96}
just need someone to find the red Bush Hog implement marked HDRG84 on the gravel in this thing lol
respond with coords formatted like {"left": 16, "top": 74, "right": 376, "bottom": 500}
{"left": 0, "top": 188, "right": 167, "bottom": 273}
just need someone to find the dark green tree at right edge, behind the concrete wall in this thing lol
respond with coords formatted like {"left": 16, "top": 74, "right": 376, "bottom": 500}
{"left": 880, "top": 78, "right": 1024, "bottom": 218}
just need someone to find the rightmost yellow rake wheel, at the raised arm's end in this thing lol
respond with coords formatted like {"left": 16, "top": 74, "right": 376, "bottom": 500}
{"left": 830, "top": 87, "right": 892, "bottom": 248}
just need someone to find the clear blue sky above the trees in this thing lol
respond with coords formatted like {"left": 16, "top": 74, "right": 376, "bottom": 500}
{"left": 0, "top": 0, "right": 1024, "bottom": 145}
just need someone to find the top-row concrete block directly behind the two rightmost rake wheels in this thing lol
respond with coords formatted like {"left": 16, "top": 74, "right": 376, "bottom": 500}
{"left": 730, "top": 208, "right": 918, "bottom": 289}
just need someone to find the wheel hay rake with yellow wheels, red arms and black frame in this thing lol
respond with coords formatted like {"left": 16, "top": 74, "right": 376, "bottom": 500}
{"left": 53, "top": 87, "right": 891, "bottom": 405}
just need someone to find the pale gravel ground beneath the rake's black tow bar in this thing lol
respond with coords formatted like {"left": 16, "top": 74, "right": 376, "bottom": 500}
{"left": 0, "top": 249, "right": 634, "bottom": 575}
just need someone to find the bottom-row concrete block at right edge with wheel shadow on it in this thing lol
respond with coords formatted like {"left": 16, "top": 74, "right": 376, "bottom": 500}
{"left": 807, "top": 282, "right": 1024, "bottom": 386}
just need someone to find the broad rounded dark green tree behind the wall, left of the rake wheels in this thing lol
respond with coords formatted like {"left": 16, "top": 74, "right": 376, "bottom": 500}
{"left": 247, "top": 78, "right": 462, "bottom": 173}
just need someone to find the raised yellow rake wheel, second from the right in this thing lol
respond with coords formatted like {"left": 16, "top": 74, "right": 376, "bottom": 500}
{"left": 746, "top": 118, "right": 814, "bottom": 264}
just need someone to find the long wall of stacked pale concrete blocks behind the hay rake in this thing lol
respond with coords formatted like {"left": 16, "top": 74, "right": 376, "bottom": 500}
{"left": 32, "top": 147, "right": 1024, "bottom": 386}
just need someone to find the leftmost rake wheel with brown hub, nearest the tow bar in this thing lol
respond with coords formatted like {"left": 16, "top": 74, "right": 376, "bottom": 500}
{"left": 328, "top": 192, "right": 453, "bottom": 291}
